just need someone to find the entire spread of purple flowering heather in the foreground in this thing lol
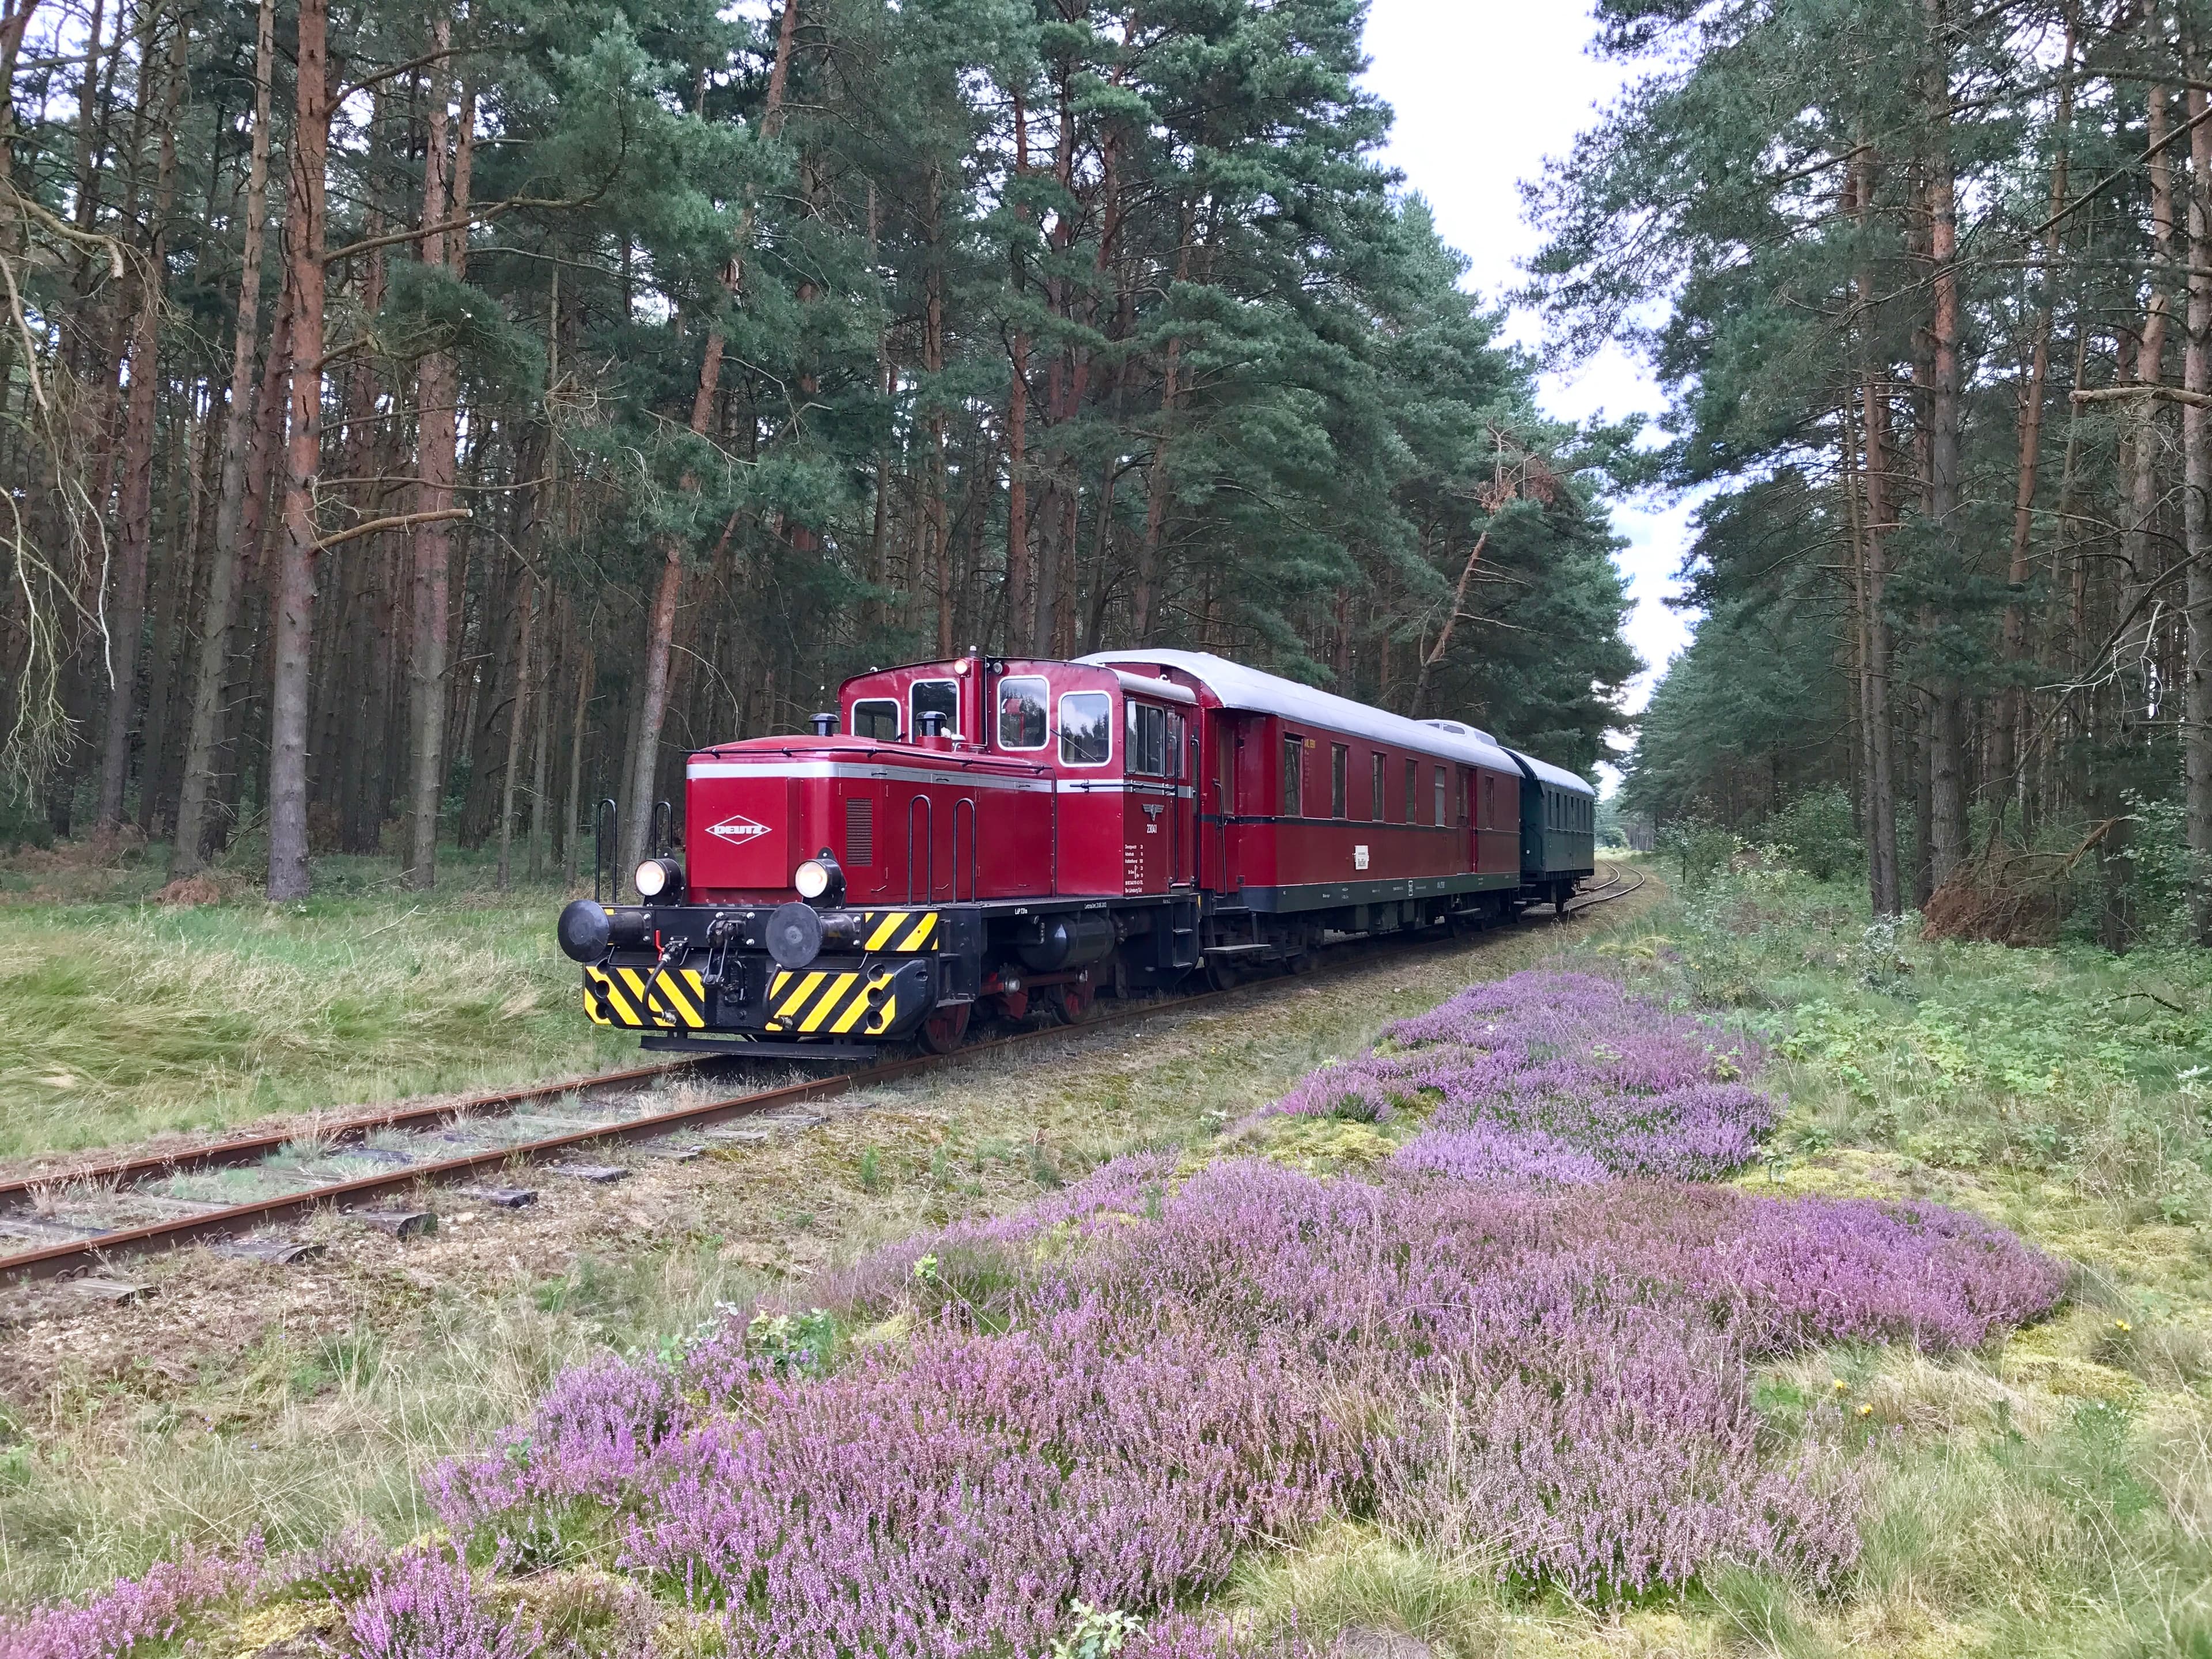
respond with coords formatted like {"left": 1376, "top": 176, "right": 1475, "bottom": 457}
{"left": 0, "top": 975, "right": 2062, "bottom": 1659}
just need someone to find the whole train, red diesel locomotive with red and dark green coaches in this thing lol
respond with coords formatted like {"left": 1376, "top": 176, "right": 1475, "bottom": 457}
{"left": 560, "top": 650, "right": 1597, "bottom": 1059}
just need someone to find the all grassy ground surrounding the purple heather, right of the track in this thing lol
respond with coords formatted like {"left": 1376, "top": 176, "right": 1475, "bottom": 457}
{"left": 0, "top": 869, "right": 2212, "bottom": 1659}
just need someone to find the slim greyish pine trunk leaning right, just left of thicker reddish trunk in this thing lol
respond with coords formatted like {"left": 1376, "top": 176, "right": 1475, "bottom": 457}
{"left": 168, "top": 0, "right": 283, "bottom": 878}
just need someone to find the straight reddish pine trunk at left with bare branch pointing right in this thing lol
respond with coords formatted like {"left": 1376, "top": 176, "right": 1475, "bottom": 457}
{"left": 268, "top": 0, "right": 329, "bottom": 900}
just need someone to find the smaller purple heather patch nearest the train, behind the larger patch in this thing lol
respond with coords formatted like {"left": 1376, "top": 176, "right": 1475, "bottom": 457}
{"left": 1274, "top": 974, "right": 1774, "bottom": 1183}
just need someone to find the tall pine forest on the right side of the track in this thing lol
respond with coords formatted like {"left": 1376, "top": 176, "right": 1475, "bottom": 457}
{"left": 1575, "top": 0, "right": 2212, "bottom": 945}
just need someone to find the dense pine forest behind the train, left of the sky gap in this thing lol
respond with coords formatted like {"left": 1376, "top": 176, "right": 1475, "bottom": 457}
{"left": 0, "top": 0, "right": 1646, "bottom": 898}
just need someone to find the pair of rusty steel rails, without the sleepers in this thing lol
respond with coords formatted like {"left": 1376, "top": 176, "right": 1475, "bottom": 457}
{"left": 0, "top": 872, "right": 1643, "bottom": 1287}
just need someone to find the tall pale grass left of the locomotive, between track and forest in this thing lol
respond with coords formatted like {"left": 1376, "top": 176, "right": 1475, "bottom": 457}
{"left": 0, "top": 850, "right": 635, "bottom": 1159}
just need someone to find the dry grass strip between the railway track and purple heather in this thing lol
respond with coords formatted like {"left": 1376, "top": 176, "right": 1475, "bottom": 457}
{"left": 0, "top": 871, "right": 1641, "bottom": 1610}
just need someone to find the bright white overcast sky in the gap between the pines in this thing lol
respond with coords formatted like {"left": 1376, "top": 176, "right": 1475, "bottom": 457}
{"left": 1367, "top": 0, "right": 1690, "bottom": 778}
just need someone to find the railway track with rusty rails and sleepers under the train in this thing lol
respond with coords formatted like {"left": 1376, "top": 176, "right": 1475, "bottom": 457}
{"left": 0, "top": 867, "right": 1643, "bottom": 1294}
